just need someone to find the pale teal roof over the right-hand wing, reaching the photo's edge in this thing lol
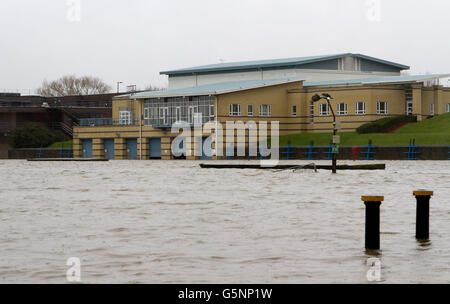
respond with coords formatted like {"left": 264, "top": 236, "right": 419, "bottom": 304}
{"left": 303, "top": 74, "right": 450, "bottom": 87}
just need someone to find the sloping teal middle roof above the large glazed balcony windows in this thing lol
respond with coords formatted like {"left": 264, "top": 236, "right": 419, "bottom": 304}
{"left": 123, "top": 78, "right": 303, "bottom": 98}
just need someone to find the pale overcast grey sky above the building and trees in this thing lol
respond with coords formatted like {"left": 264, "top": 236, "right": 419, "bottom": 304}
{"left": 0, "top": 0, "right": 450, "bottom": 90}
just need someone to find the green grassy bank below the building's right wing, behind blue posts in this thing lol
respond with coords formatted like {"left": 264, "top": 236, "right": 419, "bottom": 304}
{"left": 280, "top": 113, "right": 450, "bottom": 146}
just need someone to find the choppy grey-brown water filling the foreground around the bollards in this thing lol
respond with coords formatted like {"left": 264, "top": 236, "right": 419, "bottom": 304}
{"left": 0, "top": 161, "right": 450, "bottom": 283}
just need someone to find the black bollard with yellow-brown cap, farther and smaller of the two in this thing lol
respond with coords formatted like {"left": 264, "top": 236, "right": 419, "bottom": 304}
{"left": 413, "top": 190, "right": 434, "bottom": 240}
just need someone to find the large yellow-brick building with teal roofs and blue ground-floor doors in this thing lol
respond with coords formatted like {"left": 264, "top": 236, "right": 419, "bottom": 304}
{"left": 74, "top": 54, "right": 450, "bottom": 159}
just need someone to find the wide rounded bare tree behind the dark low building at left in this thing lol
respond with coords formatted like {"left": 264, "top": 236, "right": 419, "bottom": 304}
{"left": 37, "top": 75, "right": 111, "bottom": 97}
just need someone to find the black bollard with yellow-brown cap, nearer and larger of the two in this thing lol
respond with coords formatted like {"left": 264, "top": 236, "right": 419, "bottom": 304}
{"left": 362, "top": 196, "right": 384, "bottom": 250}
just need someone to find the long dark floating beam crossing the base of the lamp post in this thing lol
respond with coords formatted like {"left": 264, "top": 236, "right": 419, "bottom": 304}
{"left": 200, "top": 164, "right": 386, "bottom": 170}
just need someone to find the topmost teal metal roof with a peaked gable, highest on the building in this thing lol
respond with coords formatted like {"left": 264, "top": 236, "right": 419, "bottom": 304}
{"left": 160, "top": 53, "right": 410, "bottom": 76}
